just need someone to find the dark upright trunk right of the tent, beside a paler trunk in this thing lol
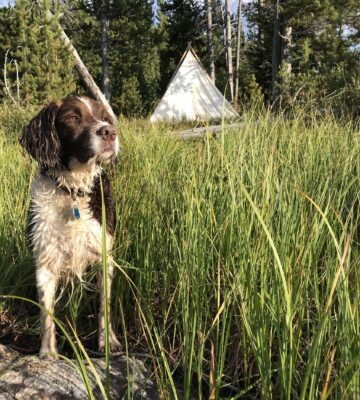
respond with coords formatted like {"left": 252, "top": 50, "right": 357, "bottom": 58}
{"left": 271, "top": 0, "right": 283, "bottom": 105}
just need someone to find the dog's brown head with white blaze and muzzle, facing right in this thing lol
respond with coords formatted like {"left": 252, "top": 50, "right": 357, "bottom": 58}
{"left": 20, "top": 96, "right": 119, "bottom": 170}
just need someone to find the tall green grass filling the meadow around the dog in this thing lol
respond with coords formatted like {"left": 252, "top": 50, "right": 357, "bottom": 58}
{"left": 0, "top": 107, "right": 360, "bottom": 399}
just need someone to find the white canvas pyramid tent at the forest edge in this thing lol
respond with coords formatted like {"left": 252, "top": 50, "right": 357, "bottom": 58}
{"left": 150, "top": 45, "right": 238, "bottom": 122}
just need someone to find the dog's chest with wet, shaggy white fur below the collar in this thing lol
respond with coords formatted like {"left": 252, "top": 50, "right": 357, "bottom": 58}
{"left": 30, "top": 178, "right": 111, "bottom": 275}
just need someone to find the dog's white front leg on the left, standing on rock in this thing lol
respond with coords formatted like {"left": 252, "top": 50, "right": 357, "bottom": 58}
{"left": 36, "top": 268, "right": 58, "bottom": 360}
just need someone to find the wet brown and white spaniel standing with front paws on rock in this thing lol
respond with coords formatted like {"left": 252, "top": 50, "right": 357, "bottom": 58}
{"left": 20, "top": 96, "right": 120, "bottom": 359}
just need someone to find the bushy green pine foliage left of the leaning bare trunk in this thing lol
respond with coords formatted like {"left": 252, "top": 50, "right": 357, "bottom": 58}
{"left": 0, "top": 0, "right": 75, "bottom": 104}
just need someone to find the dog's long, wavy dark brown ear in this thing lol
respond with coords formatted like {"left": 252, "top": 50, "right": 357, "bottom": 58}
{"left": 20, "top": 102, "right": 62, "bottom": 169}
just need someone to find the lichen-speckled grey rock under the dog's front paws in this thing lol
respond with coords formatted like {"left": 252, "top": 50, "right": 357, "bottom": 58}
{"left": 0, "top": 345, "right": 159, "bottom": 400}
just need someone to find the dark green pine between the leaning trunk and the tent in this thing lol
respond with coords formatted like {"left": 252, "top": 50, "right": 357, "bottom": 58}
{"left": 110, "top": 0, "right": 160, "bottom": 115}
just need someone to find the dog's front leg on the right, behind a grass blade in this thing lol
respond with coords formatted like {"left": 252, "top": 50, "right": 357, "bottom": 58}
{"left": 98, "top": 260, "right": 121, "bottom": 352}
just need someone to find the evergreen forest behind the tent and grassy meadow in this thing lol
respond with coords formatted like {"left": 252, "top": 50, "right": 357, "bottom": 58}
{"left": 0, "top": 0, "right": 360, "bottom": 118}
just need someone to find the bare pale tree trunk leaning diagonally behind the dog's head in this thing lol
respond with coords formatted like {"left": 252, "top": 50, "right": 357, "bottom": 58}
{"left": 47, "top": 11, "right": 117, "bottom": 121}
